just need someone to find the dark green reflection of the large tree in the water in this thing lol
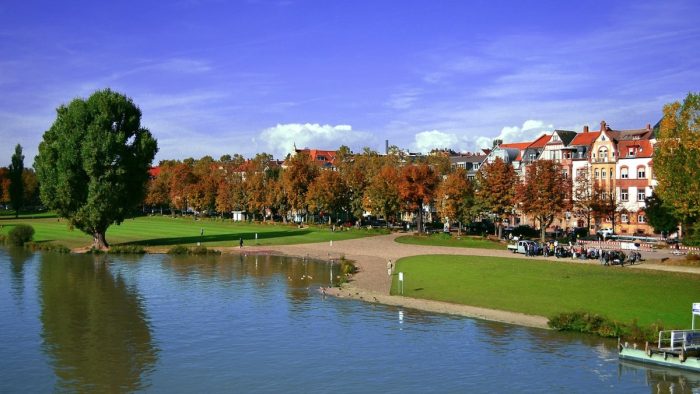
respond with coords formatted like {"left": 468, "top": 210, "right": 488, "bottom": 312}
{"left": 39, "top": 255, "right": 157, "bottom": 392}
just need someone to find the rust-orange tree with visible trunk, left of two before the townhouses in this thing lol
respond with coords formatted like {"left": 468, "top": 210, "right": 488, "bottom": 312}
{"left": 476, "top": 157, "right": 518, "bottom": 238}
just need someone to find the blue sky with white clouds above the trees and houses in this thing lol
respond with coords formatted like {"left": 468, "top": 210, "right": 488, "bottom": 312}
{"left": 0, "top": 0, "right": 700, "bottom": 166}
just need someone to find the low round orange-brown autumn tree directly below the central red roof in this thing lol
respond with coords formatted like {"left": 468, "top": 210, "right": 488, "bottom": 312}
{"left": 306, "top": 171, "right": 348, "bottom": 224}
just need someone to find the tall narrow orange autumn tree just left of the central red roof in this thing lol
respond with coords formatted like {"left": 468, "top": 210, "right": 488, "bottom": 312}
{"left": 282, "top": 153, "right": 319, "bottom": 222}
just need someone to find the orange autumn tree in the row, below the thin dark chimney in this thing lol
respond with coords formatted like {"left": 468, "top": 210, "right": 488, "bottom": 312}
{"left": 363, "top": 164, "right": 401, "bottom": 223}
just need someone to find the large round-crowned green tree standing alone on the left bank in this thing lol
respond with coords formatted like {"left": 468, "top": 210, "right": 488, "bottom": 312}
{"left": 34, "top": 89, "right": 158, "bottom": 249}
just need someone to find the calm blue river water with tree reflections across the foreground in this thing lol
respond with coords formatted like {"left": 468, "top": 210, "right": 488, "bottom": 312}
{"left": 0, "top": 249, "right": 700, "bottom": 393}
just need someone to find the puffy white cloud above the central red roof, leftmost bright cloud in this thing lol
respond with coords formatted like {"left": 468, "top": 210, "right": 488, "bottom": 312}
{"left": 255, "top": 123, "right": 369, "bottom": 158}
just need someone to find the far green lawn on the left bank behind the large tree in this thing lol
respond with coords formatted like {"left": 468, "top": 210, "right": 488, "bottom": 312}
{"left": 0, "top": 215, "right": 382, "bottom": 248}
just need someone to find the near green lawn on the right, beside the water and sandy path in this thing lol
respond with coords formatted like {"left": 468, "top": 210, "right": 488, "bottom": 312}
{"left": 391, "top": 255, "right": 700, "bottom": 328}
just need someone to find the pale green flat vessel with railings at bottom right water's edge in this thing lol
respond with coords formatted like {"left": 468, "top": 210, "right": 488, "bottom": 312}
{"left": 618, "top": 303, "right": 700, "bottom": 373}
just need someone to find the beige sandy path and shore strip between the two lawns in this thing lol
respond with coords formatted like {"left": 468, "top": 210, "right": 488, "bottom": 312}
{"left": 217, "top": 233, "right": 700, "bottom": 328}
